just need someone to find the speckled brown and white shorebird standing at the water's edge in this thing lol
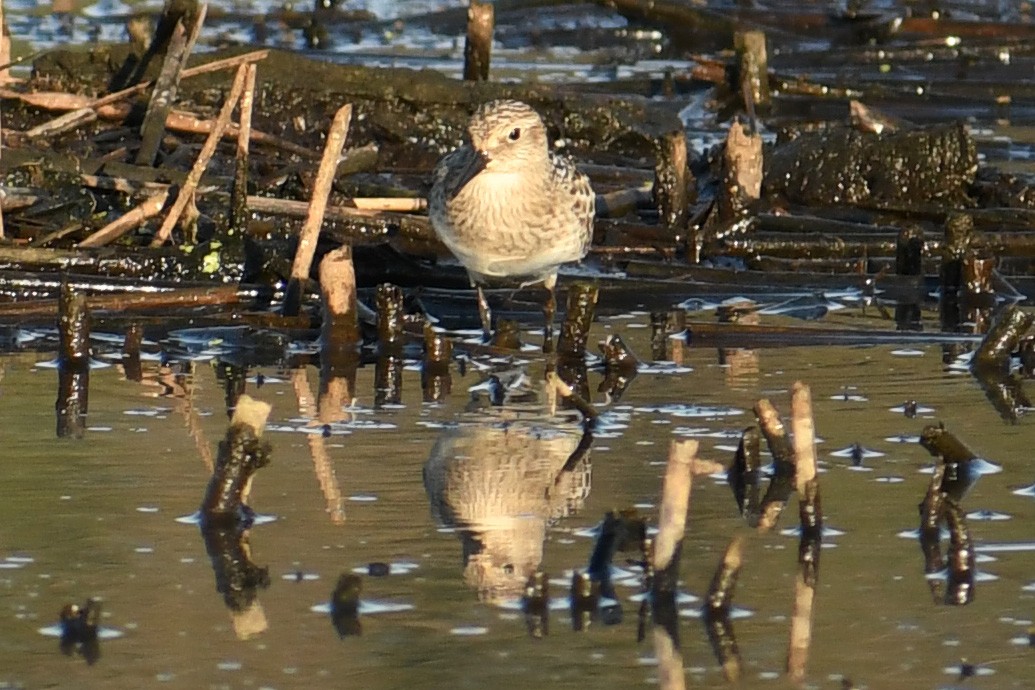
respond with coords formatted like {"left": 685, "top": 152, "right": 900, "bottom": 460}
{"left": 427, "top": 100, "right": 596, "bottom": 350}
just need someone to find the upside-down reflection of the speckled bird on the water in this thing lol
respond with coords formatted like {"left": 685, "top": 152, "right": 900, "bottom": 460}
{"left": 424, "top": 411, "right": 592, "bottom": 603}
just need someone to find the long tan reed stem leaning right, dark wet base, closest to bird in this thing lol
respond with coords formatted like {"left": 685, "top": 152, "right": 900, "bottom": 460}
{"left": 284, "top": 103, "right": 352, "bottom": 317}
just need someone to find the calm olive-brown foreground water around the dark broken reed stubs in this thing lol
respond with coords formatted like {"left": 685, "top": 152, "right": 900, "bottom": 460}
{"left": 0, "top": 317, "right": 1035, "bottom": 688}
